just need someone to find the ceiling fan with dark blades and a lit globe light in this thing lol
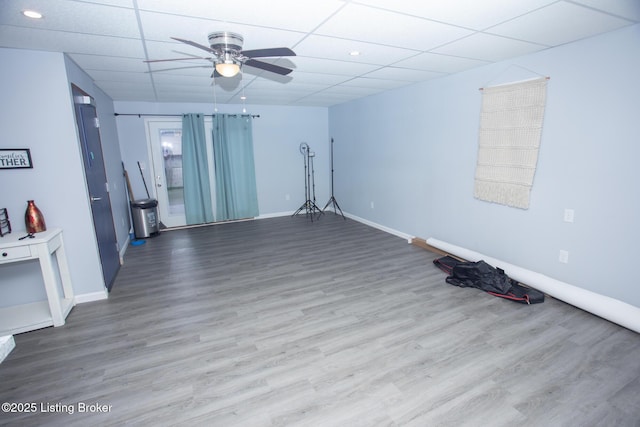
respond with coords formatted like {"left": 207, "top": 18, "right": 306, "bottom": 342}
{"left": 144, "top": 31, "right": 296, "bottom": 77}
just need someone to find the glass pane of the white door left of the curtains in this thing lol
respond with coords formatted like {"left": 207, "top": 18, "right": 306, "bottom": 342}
{"left": 160, "top": 129, "right": 184, "bottom": 214}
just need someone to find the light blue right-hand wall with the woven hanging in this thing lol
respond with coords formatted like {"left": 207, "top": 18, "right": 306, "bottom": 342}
{"left": 329, "top": 25, "right": 640, "bottom": 307}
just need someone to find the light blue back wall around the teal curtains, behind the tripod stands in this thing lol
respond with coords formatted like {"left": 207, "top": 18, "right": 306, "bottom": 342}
{"left": 114, "top": 101, "right": 330, "bottom": 216}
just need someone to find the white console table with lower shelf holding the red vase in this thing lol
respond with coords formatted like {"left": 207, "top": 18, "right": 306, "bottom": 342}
{"left": 0, "top": 228, "right": 75, "bottom": 336}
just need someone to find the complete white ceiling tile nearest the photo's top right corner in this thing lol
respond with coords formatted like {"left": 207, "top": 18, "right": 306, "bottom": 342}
{"left": 488, "top": 1, "right": 630, "bottom": 46}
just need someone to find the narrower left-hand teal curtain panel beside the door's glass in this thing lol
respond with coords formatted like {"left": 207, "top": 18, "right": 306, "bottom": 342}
{"left": 182, "top": 114, "right": 213, "bottom": 224}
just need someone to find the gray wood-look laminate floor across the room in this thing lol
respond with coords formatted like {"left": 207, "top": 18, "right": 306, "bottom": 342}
{"left": 0, "top": 214, "right": 640, "bottom": 427}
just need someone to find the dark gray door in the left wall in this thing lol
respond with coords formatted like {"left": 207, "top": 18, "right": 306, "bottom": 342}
{"left": 73, "top": 86, "right": 120, "bottom": 290}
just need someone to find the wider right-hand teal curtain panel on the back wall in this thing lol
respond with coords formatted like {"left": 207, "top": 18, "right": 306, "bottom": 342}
{"left": 213, "top": 114, "right": 258, "bottom": 221}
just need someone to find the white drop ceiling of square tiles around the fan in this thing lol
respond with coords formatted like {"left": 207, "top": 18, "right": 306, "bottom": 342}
{"left": 0, "top": 0, "right": 640, "bottom": 107}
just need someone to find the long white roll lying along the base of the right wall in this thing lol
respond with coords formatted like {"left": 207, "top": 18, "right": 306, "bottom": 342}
{"left": 427, "top": 238, "right": 640, "bottom": 333}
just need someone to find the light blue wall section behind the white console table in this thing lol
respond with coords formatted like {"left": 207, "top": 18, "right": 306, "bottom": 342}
{"left": 0, "top": 49, "right": 110, "bottom": 306}
